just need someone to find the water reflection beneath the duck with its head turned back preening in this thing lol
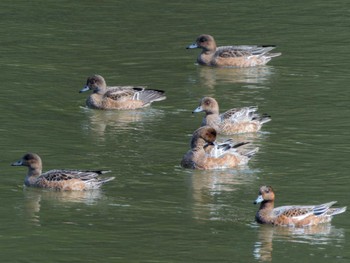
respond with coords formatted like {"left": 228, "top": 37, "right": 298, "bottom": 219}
{"left": 191, "top": 167, "right": 255, "bottom": 220}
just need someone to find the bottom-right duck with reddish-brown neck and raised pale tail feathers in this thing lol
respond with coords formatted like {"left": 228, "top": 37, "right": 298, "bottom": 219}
{"left": 254, "top": 186, "right": 346, "bottom": 227}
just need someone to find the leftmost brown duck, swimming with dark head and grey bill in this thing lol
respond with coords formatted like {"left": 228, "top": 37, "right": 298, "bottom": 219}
{"left": 11, "top": 153, "right": 115, "bottom": 191}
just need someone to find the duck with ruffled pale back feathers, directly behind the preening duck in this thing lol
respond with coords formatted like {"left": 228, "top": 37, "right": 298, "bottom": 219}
{"left": 192, "top": 97, "right": 271, "bottom": 135}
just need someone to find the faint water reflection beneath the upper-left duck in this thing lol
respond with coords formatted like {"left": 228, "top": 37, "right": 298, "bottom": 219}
{"left": 82, "top": 107, "right": 164, "bottom": 138}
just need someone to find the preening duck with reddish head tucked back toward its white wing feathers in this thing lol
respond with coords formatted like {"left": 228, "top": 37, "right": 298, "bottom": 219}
{"left": 181, "top": 126, "right": 259, "bottom": 170}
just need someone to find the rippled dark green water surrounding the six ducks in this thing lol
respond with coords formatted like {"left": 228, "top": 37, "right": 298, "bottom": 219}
{"left": 0, "top": 0, "right": 350, "bottom": 262}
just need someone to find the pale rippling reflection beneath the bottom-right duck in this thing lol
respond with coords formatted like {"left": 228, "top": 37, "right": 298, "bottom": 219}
{"left": 253, "top": 223, "right": 344, "bottom": 261}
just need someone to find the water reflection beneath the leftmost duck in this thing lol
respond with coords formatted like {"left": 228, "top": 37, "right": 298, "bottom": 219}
{"left": 24, "top": 188, "right": 103, "bottom": 225}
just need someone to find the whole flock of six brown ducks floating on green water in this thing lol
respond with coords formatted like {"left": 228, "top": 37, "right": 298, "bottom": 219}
{"left": 12, "top": 34, "right": 346, "bottom": 227}
